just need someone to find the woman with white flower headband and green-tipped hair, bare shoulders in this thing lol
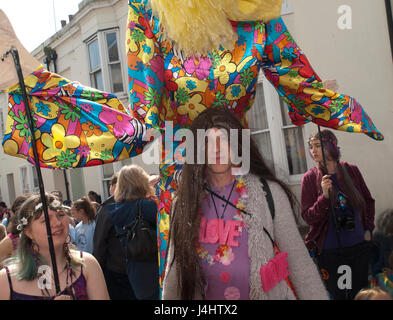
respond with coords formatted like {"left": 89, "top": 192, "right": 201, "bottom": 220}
{"left": 0, "top": 194, "right": 108, "bottom": 300}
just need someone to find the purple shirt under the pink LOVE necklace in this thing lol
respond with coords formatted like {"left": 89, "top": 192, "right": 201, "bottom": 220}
{"left": 198, "top": 180, "right": 250, "bottom": 300}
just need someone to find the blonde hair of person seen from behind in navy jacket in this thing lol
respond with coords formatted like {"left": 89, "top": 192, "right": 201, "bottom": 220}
{"left": 114, "top": 164, "right": 152, "bottom": 202}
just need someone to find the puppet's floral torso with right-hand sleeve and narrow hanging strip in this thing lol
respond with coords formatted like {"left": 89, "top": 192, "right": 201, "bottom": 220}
{"left": 127, "top": 0, "right": 383, "bottom": 292}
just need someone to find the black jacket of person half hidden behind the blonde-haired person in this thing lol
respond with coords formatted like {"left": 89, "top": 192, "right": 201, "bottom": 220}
{"left": 93, "top": 196, "right": 126, "bottom": 274}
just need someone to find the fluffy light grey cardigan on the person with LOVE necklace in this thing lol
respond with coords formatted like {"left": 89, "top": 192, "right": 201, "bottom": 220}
{"left": 162, "top": 174, "right": 329, "bottom": 300}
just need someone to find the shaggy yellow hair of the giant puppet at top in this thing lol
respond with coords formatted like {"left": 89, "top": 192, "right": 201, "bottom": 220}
{"left": 150, "top": 0, "right": 282, "bottom": 57}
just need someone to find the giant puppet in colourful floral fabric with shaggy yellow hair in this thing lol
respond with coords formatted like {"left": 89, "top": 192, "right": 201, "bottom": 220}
{"left": 3, "top": 0, "right": 383, "bottom": 292}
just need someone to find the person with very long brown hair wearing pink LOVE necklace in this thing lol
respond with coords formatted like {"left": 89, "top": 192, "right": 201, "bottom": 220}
{"left": 163, "top": 107, "right": 328, "bottom": 300}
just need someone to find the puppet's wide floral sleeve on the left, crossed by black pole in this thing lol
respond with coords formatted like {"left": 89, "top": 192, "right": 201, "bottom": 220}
{"left": 3, "top": 68, "right": 146, "bottom": 168}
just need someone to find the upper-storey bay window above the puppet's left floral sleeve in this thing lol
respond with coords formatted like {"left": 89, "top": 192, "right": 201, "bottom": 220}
{"left": 87, "top": 29, "right": 124, "bottom": 93}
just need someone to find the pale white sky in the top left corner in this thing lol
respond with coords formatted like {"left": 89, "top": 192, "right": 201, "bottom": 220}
{"left": 0, "top": 0, "right": 82, "bottom": 51}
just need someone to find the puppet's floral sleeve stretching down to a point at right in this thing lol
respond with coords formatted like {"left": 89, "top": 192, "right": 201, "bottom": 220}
{"left": 263, "top": 18, "right": 383, "bottom": 140}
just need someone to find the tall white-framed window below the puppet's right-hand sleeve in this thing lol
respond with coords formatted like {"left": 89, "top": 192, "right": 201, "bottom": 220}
{"left": 247, "top": 73, "right": 307, "bottom": 184}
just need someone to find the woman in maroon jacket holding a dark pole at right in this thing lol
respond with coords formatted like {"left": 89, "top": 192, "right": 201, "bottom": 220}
{"left": 301, "top": 130, "right": 375, "bottom": 299}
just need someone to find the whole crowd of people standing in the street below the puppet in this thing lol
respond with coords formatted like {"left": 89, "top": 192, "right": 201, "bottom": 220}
{"left": 0, "top": 107, "right": 393, "bottom": 300}
